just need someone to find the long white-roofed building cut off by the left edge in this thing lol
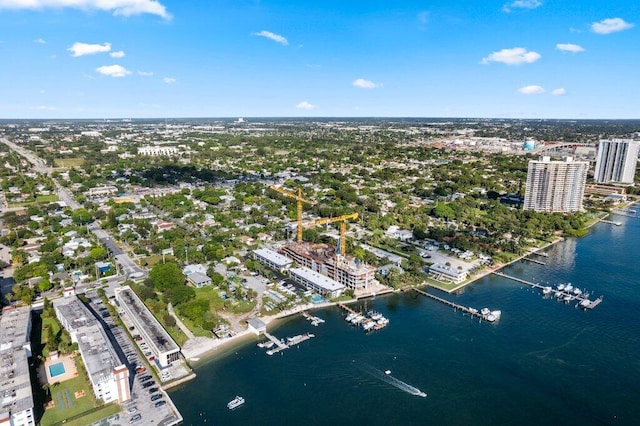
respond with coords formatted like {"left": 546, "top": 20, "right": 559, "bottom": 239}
{"left": 0, "top": 306, "right": 36, "bottom": 426}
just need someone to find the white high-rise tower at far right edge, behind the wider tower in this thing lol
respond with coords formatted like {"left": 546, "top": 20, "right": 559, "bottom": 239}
{"left": 593, "top": 139, "right": 640, "bottom": 183}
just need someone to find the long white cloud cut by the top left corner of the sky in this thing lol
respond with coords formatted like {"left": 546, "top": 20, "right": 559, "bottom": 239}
{"left": 0, "top": 0, "right": 171, "bottom": 19}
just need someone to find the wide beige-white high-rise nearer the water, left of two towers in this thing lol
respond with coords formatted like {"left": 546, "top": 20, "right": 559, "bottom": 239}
{"left": 524, "top": 157, "right": 589, "bottom": 213}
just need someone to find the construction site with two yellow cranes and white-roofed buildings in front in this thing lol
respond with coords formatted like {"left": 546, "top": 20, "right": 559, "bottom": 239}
{"left": 251, "top": 186, "right": 380, "bottom": 297}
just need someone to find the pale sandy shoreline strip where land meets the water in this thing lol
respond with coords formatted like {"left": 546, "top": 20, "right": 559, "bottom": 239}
{"left": 175, "top": 205, "right": 636, "bottom": 364}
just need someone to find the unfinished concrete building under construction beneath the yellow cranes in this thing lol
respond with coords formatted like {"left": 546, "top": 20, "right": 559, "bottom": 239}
{"left": 278, "top": 242, "right": 376, "bottom": 290}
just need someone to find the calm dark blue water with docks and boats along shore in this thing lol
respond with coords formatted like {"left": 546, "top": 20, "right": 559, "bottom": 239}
{"left": 171, "top": 209, "right": 640, "bottom": 426}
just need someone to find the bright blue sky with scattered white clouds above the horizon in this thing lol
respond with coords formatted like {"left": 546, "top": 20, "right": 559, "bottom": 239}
{"left": 0, "top": 0, "right": 640, "bottom": 119}
